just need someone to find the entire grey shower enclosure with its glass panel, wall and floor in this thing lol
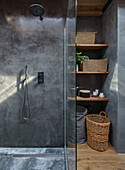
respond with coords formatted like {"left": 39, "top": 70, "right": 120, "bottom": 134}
{"left": 0, "top": 0, "right": 76, "bottom": 170}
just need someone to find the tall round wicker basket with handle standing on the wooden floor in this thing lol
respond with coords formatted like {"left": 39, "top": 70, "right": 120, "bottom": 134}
{"left": 86, "top": 111, "right": 110, "bottom": 152}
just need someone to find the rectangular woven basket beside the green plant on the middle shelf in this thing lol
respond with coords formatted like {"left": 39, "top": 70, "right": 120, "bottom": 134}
{"left": 81, "top": 59, "right": 109, "bottom": 72}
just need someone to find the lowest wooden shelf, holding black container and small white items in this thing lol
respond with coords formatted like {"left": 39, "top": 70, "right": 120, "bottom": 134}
{"left": 68, "top": 96, "right": 109, "bottom": 102}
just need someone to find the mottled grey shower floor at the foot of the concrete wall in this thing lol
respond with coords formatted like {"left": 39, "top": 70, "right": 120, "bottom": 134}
{"left": 0, "top": 148, "right": 65, "bottom": 170}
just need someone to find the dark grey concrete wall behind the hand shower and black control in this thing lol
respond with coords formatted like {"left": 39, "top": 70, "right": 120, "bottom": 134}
{"left": 0, "top": 0, "right": 64, "bottom": 147}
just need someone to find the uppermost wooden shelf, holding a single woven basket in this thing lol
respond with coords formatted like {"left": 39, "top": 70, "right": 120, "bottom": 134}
{"left": 68, "top": 44, "right": 109, "bottom": 50}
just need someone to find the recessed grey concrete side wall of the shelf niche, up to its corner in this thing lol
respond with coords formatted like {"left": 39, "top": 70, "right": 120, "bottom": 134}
{"left": 102, "top": 0, "right": 118, "bottom": 149}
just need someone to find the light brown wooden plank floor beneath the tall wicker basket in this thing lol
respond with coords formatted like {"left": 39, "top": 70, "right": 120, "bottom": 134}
{"left": 77, "top": 143, "right": 125, "bottom": 170}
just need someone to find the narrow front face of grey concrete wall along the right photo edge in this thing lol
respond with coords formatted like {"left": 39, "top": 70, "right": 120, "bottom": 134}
{"left": 117, "top": 0, "right": 125, "bottom": 153}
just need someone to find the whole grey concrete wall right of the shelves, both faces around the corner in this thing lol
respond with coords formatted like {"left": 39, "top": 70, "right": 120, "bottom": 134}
{"left": 102, "top": 0, "right": 125, "bottom": 153}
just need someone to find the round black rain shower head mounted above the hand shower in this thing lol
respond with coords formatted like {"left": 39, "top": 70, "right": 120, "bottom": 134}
{"left": 29, "top": 4, "right": 44, "bottom": 18}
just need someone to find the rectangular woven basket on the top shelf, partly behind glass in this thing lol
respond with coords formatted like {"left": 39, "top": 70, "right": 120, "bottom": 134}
{"left": 70, "top": 32, "right": 97, "bottom": 44}
